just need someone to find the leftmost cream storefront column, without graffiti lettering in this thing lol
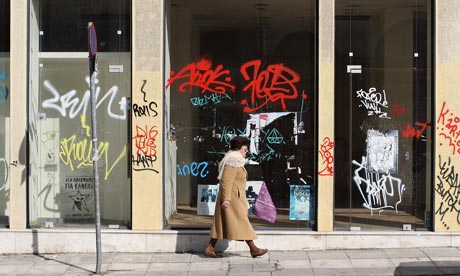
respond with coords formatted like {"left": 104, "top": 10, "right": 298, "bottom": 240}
{"left": 9, "top": 0, "right": 28, "bottom": 229}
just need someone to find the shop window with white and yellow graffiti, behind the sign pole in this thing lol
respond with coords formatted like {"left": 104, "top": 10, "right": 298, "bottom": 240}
{"left": 29, "top": 0, "right": 131, "bottom": 227}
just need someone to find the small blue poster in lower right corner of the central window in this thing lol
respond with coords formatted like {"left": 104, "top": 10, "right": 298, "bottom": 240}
{"left": 289, "top": 185, "right": 315, "bottom": 220}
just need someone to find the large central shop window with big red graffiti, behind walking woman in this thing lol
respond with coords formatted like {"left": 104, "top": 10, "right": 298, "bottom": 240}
{"left": 165, "top": 0, "right": 317, "bottom": 229}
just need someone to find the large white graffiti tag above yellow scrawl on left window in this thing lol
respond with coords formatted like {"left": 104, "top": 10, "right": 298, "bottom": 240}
{"left": 42, "top": 77, "right": 127, "bottom": 120}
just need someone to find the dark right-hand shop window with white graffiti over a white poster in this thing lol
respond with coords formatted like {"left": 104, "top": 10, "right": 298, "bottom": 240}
{"left": 334, "top": 0, "right": 433, "bottom": 230}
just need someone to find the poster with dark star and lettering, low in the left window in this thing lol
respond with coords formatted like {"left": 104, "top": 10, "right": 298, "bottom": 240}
{"left": 62, "top": 176, "right": 95, "bottom": 223}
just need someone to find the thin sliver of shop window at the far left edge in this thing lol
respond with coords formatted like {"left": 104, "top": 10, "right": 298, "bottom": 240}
{"left": 0, "top": 0, "right": 11, "bottom": 227}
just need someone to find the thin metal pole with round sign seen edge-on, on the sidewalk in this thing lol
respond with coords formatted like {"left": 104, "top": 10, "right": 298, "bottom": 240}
{"left": 88, "top": 22, "right": 102, "bottom": 274}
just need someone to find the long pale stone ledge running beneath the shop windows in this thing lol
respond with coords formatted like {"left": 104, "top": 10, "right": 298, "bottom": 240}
{"left": 0, "top": 229, "right": 460, "bottom": 254}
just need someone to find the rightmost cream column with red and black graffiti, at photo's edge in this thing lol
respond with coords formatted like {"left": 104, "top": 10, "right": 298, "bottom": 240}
{"left": 433, "top": 0, "right": 460, "bottom": 232}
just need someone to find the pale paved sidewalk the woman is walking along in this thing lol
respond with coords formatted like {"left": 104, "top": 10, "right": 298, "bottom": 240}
{"left": 0, "top": 247, "right": 460, "bottom": 276}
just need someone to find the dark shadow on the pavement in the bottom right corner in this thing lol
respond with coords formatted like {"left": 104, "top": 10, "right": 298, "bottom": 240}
{"left": 394, "top": 261, "right": 460, "bottom": 276}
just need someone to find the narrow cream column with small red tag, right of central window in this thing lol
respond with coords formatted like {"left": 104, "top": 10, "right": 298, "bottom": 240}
{"left": 317, "top": 0, "right": 334, "bottom": 232}
